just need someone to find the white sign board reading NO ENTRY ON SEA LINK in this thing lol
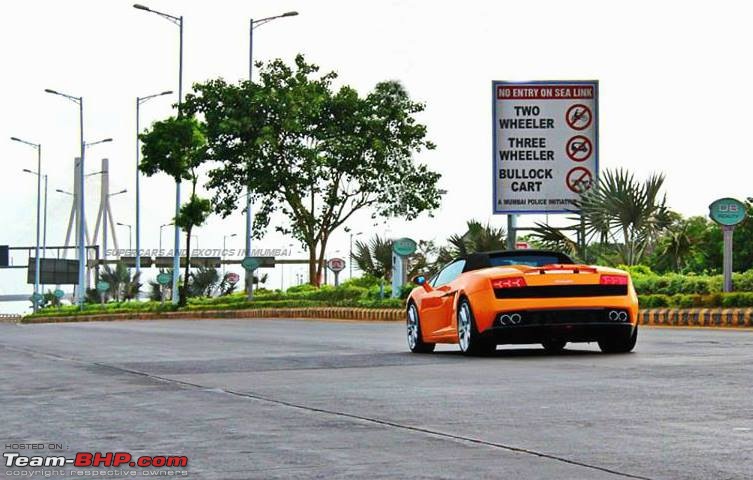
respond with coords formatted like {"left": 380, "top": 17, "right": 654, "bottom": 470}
{"left": 492, "top": 81, "right": 599, "bottom": 214}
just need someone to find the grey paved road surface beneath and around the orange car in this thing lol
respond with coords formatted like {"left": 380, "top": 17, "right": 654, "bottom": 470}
{"left": 0, "top": 320, "right": 753, "bottom": 480}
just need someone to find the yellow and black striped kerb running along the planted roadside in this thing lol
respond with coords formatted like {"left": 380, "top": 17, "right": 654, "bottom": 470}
{"left": 20, "top": 307, "right": 753, "bottom": 328}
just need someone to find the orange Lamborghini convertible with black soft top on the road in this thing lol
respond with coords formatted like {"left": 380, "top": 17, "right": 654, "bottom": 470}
{"left": 407, "top": 250, "right": 638, "bottom": 355}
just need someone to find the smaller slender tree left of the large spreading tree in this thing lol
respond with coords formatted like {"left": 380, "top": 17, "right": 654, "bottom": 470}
{"left": 139, "top": 115, "right": 212, "bottom": 305}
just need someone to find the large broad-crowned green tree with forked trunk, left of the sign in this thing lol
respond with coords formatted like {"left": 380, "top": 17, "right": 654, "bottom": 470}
{"left": 184, "top": 55, "right": 440, "bottom": 284}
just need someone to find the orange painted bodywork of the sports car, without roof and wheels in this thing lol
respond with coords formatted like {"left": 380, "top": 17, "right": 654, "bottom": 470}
{"left": 408, "top": 265, "right": 638, "bottom": 343}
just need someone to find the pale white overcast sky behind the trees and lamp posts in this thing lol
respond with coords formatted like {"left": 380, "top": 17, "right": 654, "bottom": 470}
{"left": 0, "top": 0, "right": 753, "bottom": 311}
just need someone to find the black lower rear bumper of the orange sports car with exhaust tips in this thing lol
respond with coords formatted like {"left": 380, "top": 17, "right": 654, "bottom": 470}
{"left": 481, "top": 307, "right": 636, "bottom": 344}
